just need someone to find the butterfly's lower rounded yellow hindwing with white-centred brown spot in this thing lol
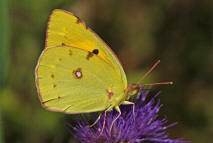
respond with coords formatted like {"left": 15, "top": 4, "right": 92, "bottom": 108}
{"left": 36, "top": 46, "right": 124, "bottom": 113}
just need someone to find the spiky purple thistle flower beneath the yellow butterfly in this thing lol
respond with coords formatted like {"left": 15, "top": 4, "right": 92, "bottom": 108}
{"left": 68, "top": 89, "right": 189, "bottom": 143}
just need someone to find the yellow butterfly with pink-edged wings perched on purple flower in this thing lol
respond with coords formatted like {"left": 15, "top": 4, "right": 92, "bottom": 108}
{"left": 35, "top": 9, "right": 171, "bottom": 132}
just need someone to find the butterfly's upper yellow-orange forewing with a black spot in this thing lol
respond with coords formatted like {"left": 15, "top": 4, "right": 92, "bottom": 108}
{"left": 46, "top": 9, "right": 127, "bottom": 88}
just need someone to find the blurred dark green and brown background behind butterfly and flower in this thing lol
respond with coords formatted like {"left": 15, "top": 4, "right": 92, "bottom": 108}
{"left": 0, "top": 0, "right": 213, "bottom": 143}
